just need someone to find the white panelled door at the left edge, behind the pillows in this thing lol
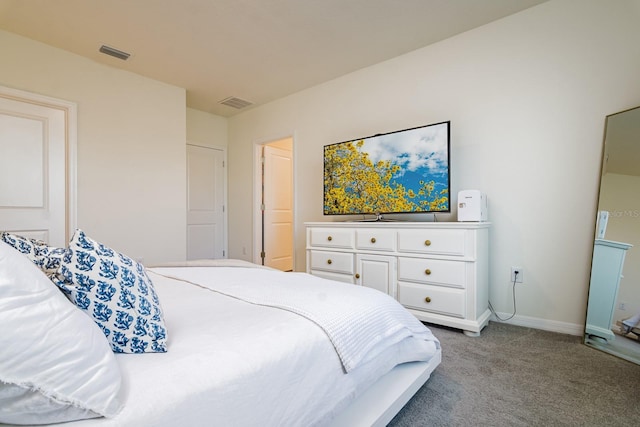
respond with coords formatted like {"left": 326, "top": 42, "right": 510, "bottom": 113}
{"left": 0, "top": 88, "right": 75, "bottom": 246}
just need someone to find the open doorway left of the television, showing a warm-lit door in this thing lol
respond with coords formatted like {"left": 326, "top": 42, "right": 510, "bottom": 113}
{"left": 254, "top": 137, "right": 294, "bottom": 271}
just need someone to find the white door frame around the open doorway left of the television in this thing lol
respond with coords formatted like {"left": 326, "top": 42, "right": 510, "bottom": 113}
{"left": 254, "top": 132, "right": 298, "bottom": 271}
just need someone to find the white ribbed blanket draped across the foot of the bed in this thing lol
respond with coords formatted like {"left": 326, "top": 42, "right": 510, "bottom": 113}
{"left": 153, "top": 267, "right": 437, "bottom": 372}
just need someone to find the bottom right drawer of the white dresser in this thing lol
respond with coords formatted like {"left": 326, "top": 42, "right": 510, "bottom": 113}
{"left": 398, "top": 283, "right": 466, "bottom": 318}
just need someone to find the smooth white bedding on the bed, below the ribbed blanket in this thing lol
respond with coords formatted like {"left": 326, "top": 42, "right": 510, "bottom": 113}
{"left": 55, "top": 268, "right": 438, "bottom": 427}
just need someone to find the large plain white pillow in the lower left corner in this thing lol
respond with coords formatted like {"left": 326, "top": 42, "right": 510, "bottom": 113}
{"left": 0, "top": 242, "right": 122, "bottom": 424}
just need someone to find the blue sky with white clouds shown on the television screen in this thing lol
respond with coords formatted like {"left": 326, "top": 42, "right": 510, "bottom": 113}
{"left": 362, "top": 123, "right": 448, "bottom": 178}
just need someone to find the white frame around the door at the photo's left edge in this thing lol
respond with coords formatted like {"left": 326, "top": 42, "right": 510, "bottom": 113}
{"left": 0, "top": 86, "right": 78, "bottom": 241}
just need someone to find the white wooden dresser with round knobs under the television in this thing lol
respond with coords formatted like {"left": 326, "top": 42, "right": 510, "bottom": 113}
{"left": 305, "top": 222, "right": 491, "bottom": 336}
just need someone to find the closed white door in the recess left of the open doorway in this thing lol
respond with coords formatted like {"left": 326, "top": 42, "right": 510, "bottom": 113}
{"left": 187, "top": 144, "right": 226, "bottom": 259}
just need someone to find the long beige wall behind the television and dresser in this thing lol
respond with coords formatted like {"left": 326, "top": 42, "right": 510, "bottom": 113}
{"left": 229, "top": 0, "right": 640, "bottom": 334}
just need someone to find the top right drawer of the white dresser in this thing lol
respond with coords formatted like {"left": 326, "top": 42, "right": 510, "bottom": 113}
{"left": 398, "top": 229, "right": 467, "bottom": 256}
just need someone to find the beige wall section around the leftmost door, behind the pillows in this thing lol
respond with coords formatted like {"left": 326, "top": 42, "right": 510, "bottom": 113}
{"left": 0, "top": 31, "right": 186, "bottom": 264}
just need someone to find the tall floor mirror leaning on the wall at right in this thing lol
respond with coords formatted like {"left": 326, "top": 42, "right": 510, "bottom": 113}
{"left": 584, "top": 107, "right": 640, "bottom": 364}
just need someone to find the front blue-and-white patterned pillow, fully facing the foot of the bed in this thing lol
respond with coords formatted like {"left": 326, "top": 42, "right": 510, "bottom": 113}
{"left": 57, "top": 230, "right": 167, "bottom": 353}
